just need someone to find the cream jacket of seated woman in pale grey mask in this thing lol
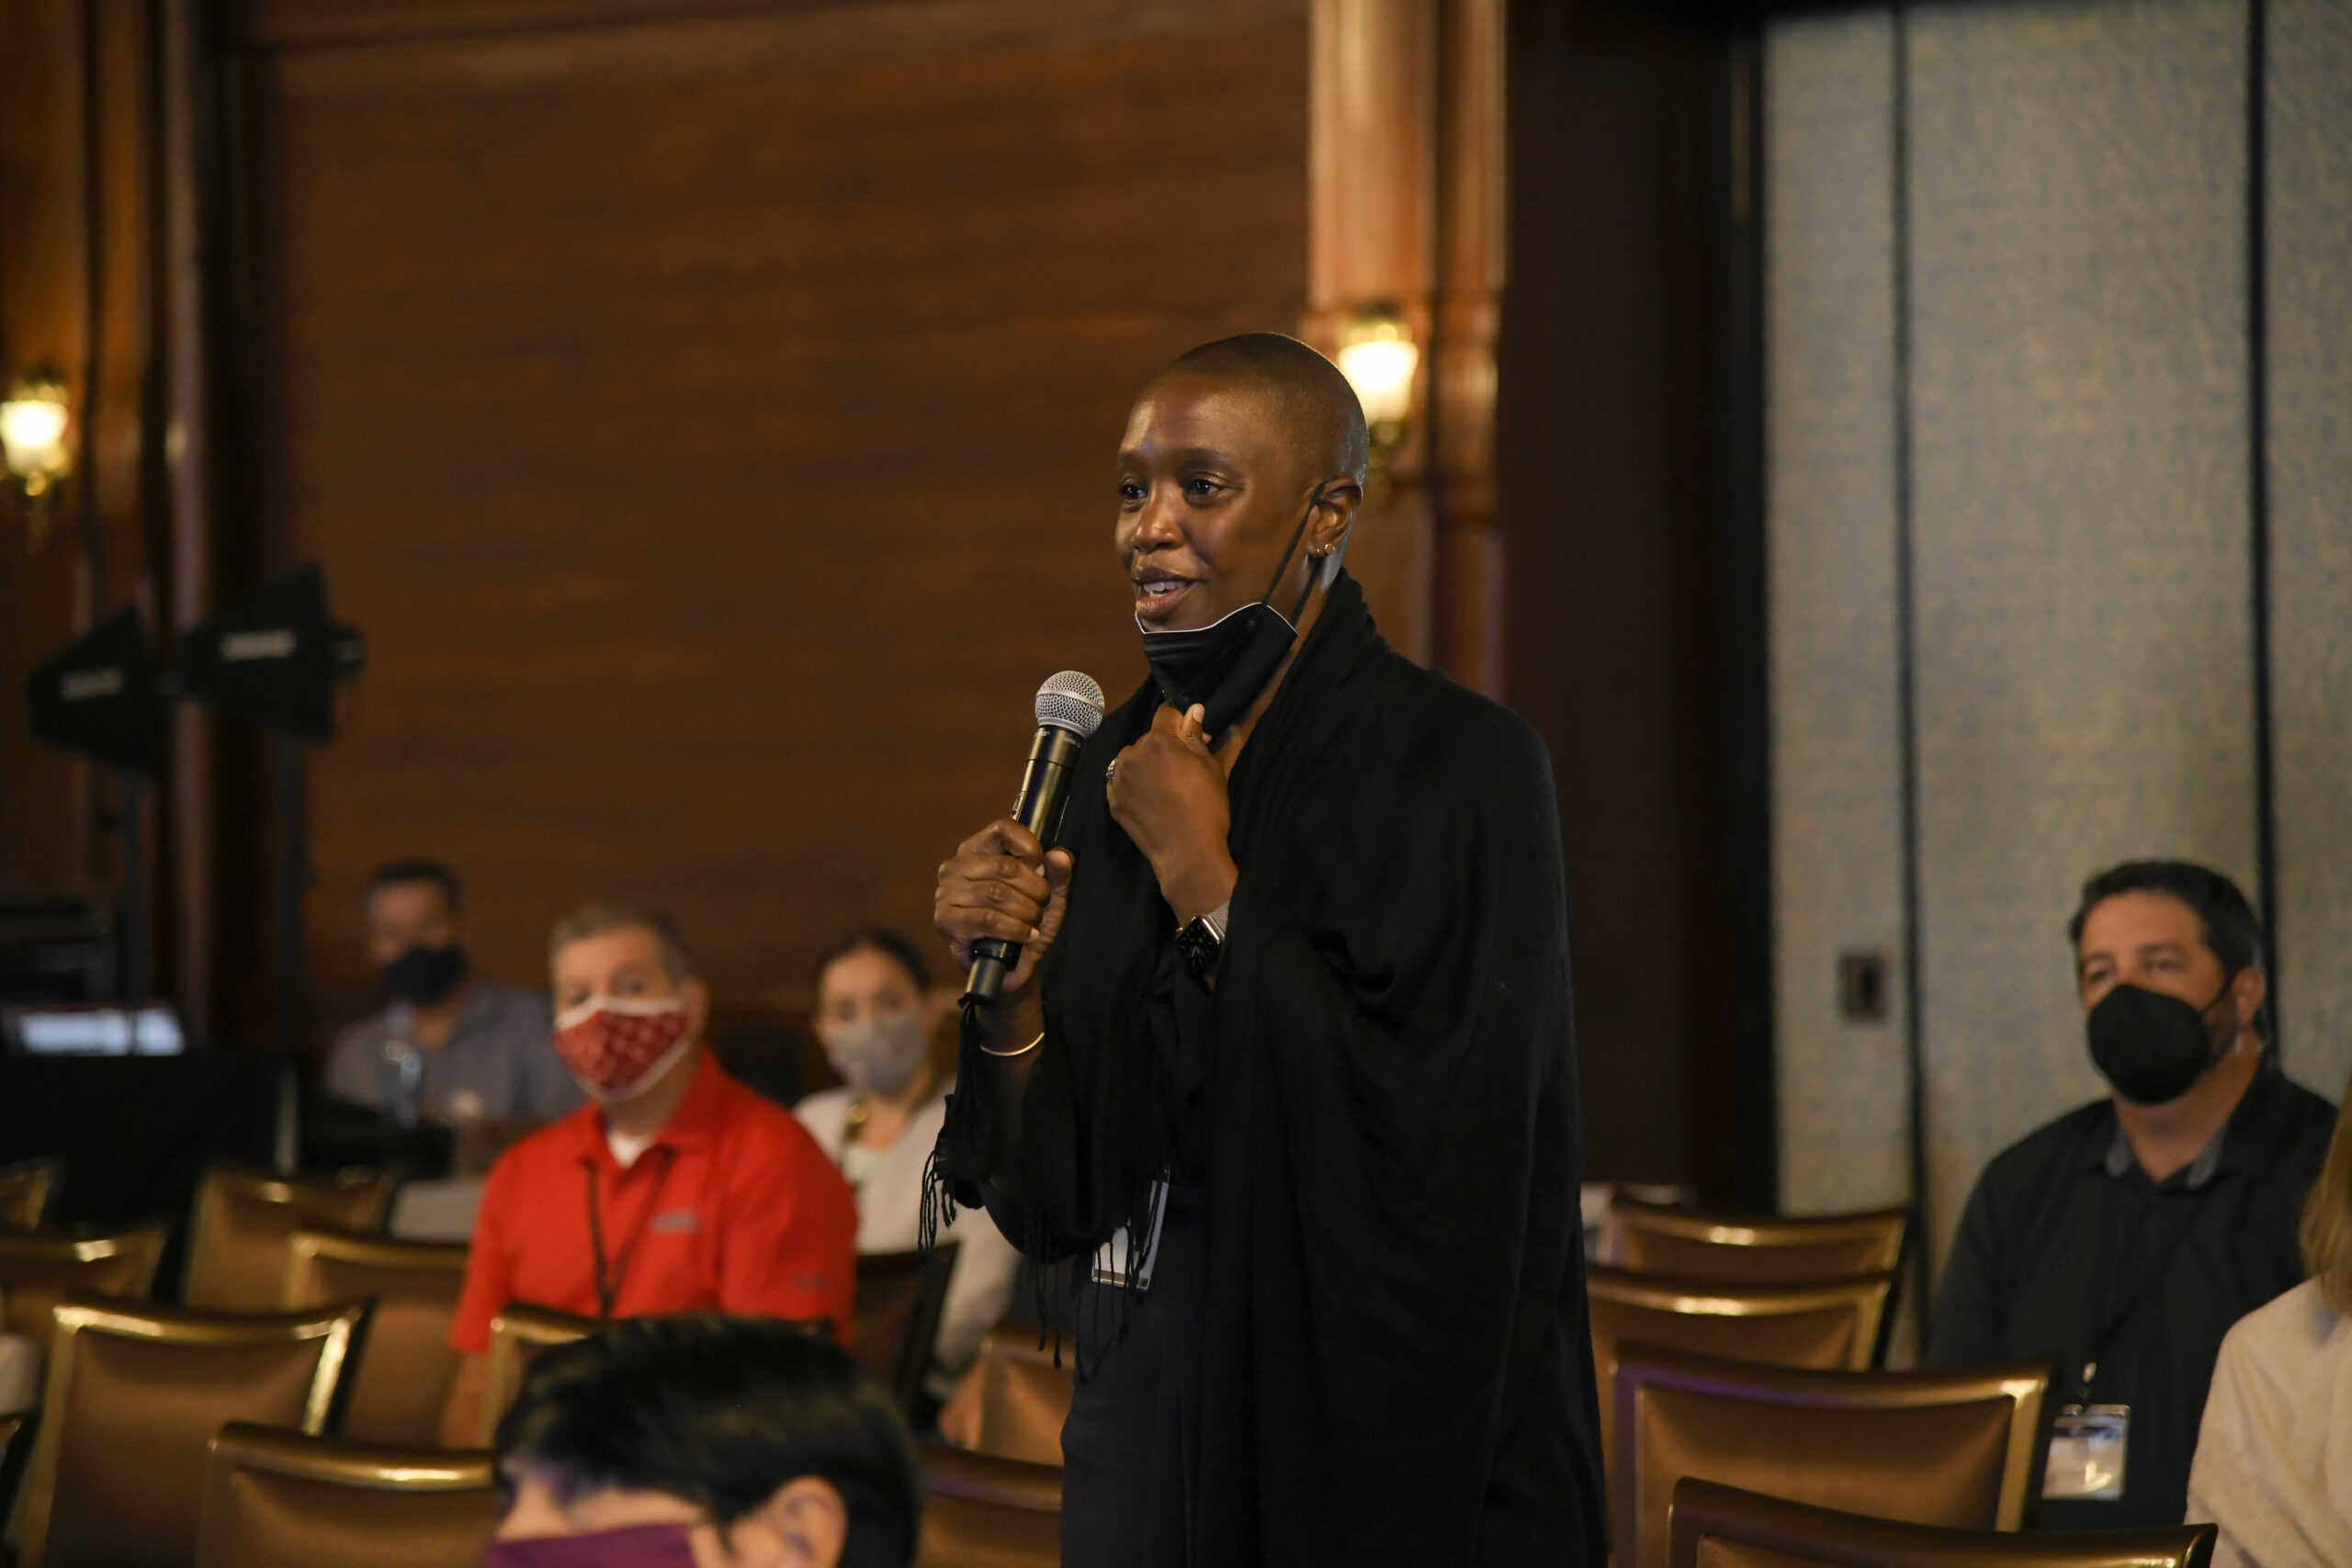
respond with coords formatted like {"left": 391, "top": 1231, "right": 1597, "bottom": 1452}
{"left": 793, "top": 1086, "right": 1021, "bottom": 1399}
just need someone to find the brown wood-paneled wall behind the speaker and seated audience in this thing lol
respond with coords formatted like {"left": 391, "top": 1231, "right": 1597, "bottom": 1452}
{"left": 231, "top": 0, "right": 1307, "bottom": 1006}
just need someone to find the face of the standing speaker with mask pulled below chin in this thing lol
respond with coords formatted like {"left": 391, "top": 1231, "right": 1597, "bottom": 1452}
{"left": 1114, "top": 374, "right": 1343, "bottom": 632}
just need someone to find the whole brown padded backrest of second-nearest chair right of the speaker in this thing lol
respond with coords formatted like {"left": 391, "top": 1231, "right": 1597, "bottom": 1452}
{"left": 1609, "top": 1345, "right": 2058, "bottom": 1568}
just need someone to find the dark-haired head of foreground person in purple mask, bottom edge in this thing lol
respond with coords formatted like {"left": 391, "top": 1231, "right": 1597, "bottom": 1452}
{"left": 482, "top": 1312, "right": 922, "bottom": 1568}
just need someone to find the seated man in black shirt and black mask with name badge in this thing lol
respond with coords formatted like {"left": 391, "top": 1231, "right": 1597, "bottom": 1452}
{"left": 1928, "top": 861, "right": 2335, "bottom": 1530}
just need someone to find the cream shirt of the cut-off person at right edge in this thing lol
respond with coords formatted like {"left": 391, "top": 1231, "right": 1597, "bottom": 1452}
{"left": 2188, "top": 1281, "right": 2352, "bottom": 1568}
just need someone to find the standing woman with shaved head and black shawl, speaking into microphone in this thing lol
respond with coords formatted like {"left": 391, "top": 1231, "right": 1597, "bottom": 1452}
{"left": 933, "top": 333, "right": 1604, "bottom": 1568}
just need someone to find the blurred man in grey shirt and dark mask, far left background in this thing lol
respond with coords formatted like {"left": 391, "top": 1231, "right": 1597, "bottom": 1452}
{"left": 327, "top": 861, "right": 581, "bottom": 1126}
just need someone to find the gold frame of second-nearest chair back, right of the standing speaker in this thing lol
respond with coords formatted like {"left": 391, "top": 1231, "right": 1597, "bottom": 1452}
{"left": 1606, "top": 1345, "right": 2058, "bottom": 1565}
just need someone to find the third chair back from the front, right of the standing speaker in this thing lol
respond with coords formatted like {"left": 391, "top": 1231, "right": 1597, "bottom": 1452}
{"left": 1585, "top": 1265, "right": 1895, "bottom": 1455}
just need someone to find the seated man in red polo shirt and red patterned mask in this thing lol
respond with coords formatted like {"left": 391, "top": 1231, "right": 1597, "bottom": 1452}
{"left": 442, "top": 909, "right": 858, "bottom": 1446}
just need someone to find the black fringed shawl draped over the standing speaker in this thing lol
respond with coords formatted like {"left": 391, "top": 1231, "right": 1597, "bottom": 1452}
{"left": 938, "top": 576, "right": 1604, "bottom": 1568}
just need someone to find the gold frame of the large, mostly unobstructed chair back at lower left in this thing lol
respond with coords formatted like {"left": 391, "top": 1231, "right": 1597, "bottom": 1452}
{"left": 18, "top": 1298, "right": 367, "bottom": 1568}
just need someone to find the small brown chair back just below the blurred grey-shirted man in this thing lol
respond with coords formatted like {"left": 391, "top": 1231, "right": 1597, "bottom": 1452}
{"left": 181, "top": 1166, "right": 398, "bottom": 1312}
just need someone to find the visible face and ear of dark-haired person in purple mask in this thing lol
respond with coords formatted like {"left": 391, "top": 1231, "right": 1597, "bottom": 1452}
{"left": 494, "top": 1470, "right": 849, "bottom": 1568}
